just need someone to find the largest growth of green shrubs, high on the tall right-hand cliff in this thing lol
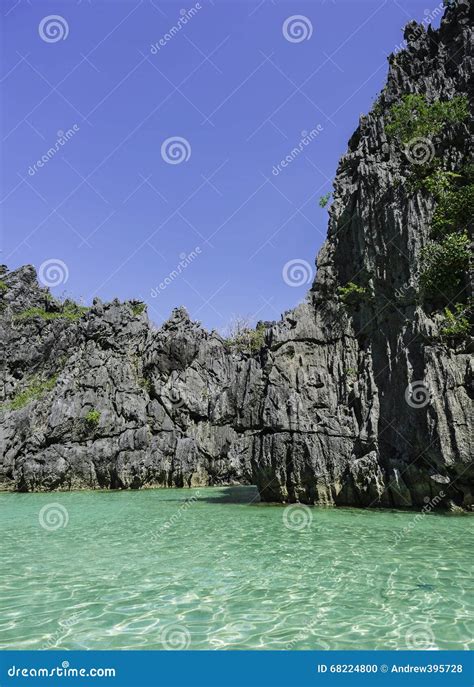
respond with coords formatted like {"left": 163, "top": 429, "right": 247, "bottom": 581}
{"left": 386, "top": 94, "right": 474, "bottom": 318}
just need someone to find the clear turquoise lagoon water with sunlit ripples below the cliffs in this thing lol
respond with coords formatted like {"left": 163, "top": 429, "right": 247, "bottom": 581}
{"left": 0, "top": 487, "right": 474, "bottom": 649}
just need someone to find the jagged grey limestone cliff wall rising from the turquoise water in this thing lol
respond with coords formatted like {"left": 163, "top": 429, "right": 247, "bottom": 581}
{"left": 0, "top": 0, "right": 474, "bottom": 508}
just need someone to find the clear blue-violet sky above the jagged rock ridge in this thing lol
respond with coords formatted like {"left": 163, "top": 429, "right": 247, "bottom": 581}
{"left": 0, "top": 0, "right": 442, "bottom": 332}
